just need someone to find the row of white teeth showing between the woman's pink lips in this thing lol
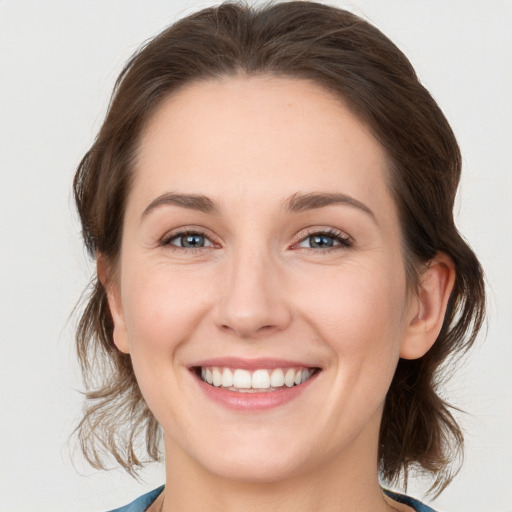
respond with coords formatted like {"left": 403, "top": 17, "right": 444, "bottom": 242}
{"left": 195, "top": 366, "right": 320, "bottom": 393}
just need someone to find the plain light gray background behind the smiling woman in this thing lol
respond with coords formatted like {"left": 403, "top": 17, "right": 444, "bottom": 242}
{"left": 0, "top": 0, "right": 512, "bottom": 512}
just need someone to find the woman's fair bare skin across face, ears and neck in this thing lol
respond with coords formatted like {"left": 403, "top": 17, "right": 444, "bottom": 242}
{"left": 102, "top": 76, "right": 454, "bottom": 512}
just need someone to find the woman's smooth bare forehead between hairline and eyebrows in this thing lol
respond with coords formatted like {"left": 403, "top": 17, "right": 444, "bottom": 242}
{"left": 134, "top": 76, "right": 389, "bottom": 212}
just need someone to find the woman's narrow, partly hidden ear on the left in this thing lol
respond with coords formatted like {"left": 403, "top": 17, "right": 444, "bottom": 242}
{"left": 96, "top": 254, "right": 130, "bottom": 354}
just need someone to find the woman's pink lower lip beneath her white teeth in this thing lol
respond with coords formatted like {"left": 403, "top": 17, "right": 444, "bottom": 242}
{"left": 195, "top": 372, "right": 319, "bottom": 411}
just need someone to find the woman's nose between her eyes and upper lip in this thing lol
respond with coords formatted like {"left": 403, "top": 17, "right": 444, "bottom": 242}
{"left": 216, "top": 248, "right": 292, "bottom": 339}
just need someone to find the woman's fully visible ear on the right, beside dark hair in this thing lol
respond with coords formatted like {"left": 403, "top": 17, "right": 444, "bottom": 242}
{"left": 400, "top": 252, "right": 455, "bottom": 359}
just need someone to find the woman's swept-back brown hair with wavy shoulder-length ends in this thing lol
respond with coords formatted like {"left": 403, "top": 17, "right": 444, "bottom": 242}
{"left": 74, "top": 1, "right": 485, "bottom": 496}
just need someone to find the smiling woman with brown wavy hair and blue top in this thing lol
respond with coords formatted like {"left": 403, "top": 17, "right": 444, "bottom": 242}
{"left": 75, "top": 2, "right": 484, "bottom": 512}
